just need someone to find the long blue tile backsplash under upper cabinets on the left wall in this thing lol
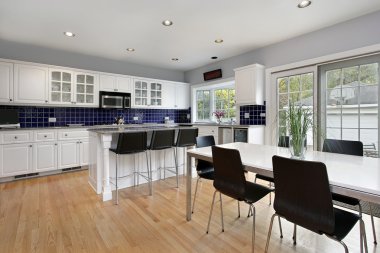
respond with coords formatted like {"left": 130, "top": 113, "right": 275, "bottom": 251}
{"left": 0, "top": 105, "right": 191, "bottom": 128}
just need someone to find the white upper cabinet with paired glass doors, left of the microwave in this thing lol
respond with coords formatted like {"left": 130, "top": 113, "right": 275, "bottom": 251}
{"left": 49, "top": 69, "right": 99, "bottom": 106}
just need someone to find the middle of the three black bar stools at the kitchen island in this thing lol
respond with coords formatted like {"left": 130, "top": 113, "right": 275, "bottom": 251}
{"left": 148, "top": 129, "right": 178, "bottom": 187}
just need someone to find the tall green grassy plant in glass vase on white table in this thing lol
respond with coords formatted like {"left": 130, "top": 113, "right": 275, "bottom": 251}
{"left": 286, "top": 103, "right": 313, "bottom": 159}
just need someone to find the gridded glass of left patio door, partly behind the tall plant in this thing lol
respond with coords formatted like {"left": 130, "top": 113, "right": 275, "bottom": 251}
{"left": 273, "top": 68, "right": 314, "bottom": 145}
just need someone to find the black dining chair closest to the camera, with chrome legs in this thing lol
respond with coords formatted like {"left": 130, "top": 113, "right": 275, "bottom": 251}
{"left": 265, "top": 156, "right": 368, "bottom": 253}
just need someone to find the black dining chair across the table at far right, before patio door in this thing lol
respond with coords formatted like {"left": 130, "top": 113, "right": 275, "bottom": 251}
{"left": 322, "top": 139, "right": 377, "bottom": 244}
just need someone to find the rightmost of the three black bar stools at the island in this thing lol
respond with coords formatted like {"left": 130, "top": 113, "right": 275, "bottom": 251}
{"left": 175, "top": 128, "right": 198, "bottom": 177}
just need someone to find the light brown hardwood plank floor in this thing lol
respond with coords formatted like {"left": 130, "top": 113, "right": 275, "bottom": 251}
{"left": 0, "top": 170, "right": 380, "bottom": 253}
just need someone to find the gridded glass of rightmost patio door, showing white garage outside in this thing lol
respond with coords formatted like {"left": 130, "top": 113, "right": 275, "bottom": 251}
{"left": 320, "top": 56, "right": 380, "bottom": 156}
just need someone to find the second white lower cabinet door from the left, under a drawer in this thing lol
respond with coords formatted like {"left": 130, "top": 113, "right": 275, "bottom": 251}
{"left": 33, "top": 142, "right": 58, "bottom": 172}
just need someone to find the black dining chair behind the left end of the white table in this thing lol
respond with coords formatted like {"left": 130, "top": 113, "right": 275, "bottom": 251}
{"left": 191, "top": 135, "right": 215, "bottom": 213}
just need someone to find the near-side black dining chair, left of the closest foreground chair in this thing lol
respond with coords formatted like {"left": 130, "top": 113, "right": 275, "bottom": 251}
{"left": 206, "top": 146, "right": 273, "bottom": 252}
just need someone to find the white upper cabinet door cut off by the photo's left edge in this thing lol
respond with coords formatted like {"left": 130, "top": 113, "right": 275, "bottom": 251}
{"left": 0, "top": 62, "right": 13, "bottom": 102}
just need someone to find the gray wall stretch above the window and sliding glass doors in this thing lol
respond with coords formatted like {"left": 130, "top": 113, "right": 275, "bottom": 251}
{"left": 185, "top": 11, "right": 380, "bottom": 84}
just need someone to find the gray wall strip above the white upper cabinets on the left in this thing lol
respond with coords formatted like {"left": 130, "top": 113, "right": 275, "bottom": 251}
{"left": 0, "top": 39, "right": 184, "bottom": 82}
